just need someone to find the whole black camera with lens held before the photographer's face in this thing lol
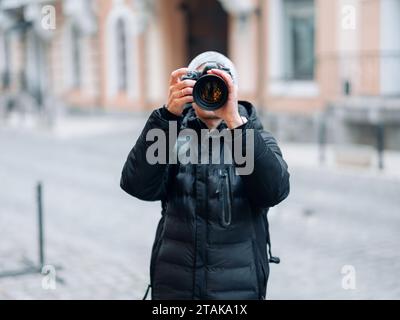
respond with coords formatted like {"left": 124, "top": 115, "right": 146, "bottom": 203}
{"left": 182, "top": 62, "right": 232, "bottom": 111}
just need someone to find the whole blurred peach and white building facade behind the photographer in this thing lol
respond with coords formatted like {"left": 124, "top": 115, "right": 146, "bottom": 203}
{"left": 0, "top": 0, "right": 400, "bottom": 146}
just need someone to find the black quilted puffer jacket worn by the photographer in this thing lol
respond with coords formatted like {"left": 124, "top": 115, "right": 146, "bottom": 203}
{"left": 121, "top": 102, "right": 289, "bottom": 299}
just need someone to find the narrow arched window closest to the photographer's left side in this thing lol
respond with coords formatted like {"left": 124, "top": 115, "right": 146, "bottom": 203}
{"left": 116, "top": 18, "right": 128, "bottom": 92}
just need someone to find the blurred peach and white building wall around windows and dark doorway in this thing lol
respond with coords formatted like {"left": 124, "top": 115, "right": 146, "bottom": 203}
{"left": 1, "top": 0, "right": 400, "bottom": 113}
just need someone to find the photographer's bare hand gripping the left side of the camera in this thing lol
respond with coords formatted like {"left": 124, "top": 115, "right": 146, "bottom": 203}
{"left": 167, "top": 68, "right": 196, "bottom": 116}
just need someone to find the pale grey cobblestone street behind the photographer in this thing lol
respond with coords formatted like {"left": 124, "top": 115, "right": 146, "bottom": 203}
{"left": 0, "top": 116, "right": 400, "bottom": 299}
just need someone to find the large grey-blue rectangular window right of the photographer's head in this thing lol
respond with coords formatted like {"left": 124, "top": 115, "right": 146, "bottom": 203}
{"left": 283, "top": 0, "right": 315, "bottom": 80}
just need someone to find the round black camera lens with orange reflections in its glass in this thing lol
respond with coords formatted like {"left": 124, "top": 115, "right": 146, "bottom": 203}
{"left": 193, "top": 75, "right": 228, "bottom": 110}
